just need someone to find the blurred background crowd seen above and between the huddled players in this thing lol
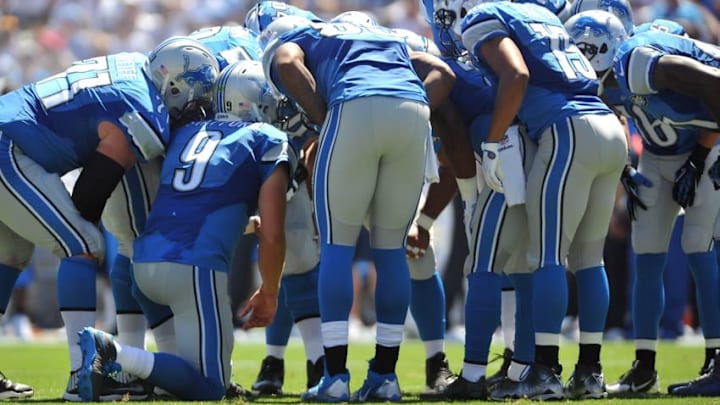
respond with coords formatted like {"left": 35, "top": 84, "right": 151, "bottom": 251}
{"left": 0, "top": 0, "right": 720, "bottom": 338}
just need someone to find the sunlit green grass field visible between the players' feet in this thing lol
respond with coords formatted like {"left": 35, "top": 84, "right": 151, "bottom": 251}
{"left": 0, "top": 340, "right": 720, "bottom": 405}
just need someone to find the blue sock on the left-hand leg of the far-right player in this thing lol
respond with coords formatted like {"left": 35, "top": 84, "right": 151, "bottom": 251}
{"left": 632, "top": 253, "right": 667, "bottom": 339}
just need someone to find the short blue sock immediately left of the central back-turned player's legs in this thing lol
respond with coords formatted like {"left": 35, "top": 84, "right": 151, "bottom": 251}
{"left": 283, "top": 267, "right": 320, "bottom": 322}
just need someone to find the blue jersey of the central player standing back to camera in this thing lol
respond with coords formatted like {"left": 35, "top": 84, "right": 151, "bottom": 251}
{"left": 263, "top": 23, "right": 428, "bottom": 107}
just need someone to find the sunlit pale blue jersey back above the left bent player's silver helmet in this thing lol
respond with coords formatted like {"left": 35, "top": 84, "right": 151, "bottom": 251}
{"left": 190, "top": 25, "right": 262, "bottom": 70}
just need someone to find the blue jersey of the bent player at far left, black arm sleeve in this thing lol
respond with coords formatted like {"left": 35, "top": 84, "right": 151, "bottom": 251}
{"left": 0, "top": 53, "right": 170, "bottom": 174}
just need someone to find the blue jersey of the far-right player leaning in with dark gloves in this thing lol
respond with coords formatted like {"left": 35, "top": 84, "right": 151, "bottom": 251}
{"left": 613, "top": 30, "right": 720, "bottom": 136}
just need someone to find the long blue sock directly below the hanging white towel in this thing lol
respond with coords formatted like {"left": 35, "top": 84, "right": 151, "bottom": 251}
{"left": 464, "top": 272, "right": 502, "bottom": 364}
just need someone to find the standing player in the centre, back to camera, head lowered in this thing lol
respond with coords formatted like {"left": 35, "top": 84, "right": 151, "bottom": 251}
{"left": 261, "top": 17, "right": 454, "bottom": 402}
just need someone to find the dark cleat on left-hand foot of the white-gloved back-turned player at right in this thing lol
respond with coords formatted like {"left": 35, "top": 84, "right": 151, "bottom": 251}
{"left": 490, "top": 363, "right": 565, "bottom": 401}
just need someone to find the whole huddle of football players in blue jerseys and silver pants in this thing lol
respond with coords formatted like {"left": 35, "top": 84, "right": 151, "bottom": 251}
{"left": 0, "top": 0, "right": 720, "bottom": 402}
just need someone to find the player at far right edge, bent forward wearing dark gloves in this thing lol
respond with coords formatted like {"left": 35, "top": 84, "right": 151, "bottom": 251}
{"left": 568, "top": 11, "right": 720, "bottom": 395}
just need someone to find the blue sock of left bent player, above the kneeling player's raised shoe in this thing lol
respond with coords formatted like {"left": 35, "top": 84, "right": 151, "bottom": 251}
{"left": 57, "top": 257, "right": 98, "bottom": 311}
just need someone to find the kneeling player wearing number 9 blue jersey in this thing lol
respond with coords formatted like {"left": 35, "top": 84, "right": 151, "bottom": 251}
{"left": 80, "top": 61, "right": 295, "bottom": 401}
